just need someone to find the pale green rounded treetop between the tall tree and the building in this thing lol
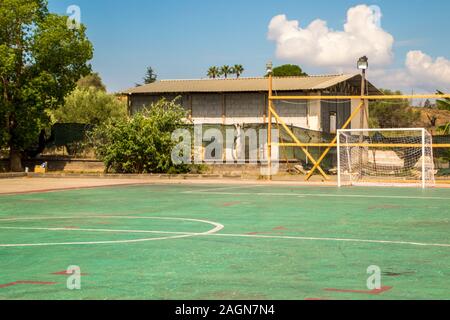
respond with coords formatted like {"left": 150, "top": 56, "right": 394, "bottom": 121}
{"left": 54, "top": 87, "right": 127, "bottom": 125}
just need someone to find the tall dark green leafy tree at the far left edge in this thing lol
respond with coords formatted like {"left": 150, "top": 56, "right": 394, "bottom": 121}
{"left": 0, "top": 0, "right": 93, "bottom": 171}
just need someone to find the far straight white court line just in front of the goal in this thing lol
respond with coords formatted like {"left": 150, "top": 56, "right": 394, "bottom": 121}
{"left": 184, "top": 191, "right": 450, "bottom": 201}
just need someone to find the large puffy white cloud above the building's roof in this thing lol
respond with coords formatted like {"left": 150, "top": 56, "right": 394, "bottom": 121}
{"left": 268, "top": 5, "right": 394, "bottom": 70}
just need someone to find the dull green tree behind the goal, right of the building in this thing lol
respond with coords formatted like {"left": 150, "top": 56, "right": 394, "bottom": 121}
{"left": 369, "top": 89, "right": 420, "bottom": 128}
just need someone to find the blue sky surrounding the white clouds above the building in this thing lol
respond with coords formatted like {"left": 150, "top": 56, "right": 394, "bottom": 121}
{"left": 49, "top": 0, "right": 450, "bottom": 91}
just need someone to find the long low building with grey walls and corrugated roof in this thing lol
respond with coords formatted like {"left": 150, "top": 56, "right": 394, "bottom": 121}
{"left": 123, "top": 74, "right": 380, "bottom": 133}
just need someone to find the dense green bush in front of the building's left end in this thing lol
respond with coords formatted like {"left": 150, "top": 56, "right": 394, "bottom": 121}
{"left": 92, "top": 99, "right": 188, "bottom": 173}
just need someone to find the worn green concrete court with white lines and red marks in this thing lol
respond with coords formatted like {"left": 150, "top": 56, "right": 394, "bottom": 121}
{"left": 0, "top": 184, "right": 450, "bottom": 300}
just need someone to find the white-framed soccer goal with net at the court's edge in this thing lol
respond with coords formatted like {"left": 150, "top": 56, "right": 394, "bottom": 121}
{"left": 337, "top": 128, "right": 435, "bottom": 188}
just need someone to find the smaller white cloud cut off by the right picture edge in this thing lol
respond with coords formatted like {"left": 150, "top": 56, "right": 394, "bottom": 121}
{"left": 405, "top": 50, "right": 450, "bottom": 91}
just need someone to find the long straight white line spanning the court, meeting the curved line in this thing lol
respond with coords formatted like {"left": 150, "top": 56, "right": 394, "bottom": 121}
{"left": 0, "top": 227, "right": 450, "bottom": 247}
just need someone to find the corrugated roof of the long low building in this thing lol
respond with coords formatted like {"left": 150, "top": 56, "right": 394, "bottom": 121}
{"left": 123, "top": 74, "right": 378, "bottom": 94}
